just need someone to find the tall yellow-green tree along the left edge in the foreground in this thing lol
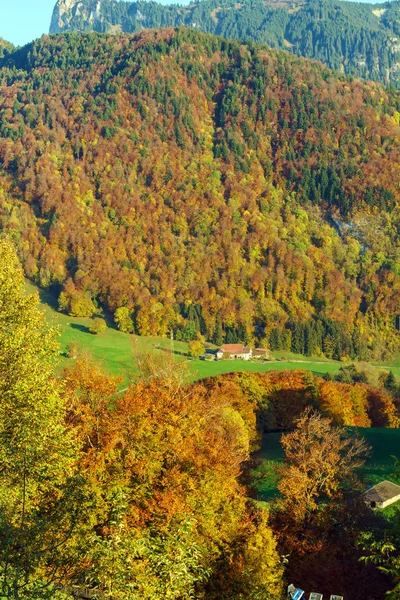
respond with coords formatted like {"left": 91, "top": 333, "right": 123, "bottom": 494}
{"left": 0, "top": 240, "right": 79, "bottom": 599}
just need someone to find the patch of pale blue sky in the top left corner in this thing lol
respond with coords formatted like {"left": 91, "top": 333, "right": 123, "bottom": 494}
{"left": 0, "top": 0, "right": 56, "bottom": 45}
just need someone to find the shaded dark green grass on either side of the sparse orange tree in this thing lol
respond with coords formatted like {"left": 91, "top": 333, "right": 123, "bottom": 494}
{"left": 255, "top": 427, "right": 400, "bottom": 504}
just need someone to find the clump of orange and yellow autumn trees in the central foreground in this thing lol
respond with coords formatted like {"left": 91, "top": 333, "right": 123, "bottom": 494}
{"left": 61, "top": 361, "right": 282, "bottom": 600}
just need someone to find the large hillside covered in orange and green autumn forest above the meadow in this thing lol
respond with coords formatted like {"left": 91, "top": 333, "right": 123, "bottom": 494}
{"left": 0, "top": 29, "right": 400, "bottom": 359}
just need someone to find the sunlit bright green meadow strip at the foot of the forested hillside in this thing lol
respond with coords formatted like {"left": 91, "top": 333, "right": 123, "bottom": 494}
{"left": 27, "top": 283, "right": 400, "bottom": 386}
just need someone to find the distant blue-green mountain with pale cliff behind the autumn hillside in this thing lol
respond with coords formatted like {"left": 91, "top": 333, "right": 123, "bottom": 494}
{"left": 50, "top": 0, "right": 400, "bottom": 84}
